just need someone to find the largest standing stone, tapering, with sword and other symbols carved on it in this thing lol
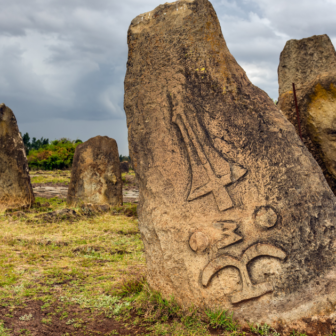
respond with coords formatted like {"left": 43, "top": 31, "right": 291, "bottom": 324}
{"left": 125, "top": 0, "right": 336, "bottom": 332}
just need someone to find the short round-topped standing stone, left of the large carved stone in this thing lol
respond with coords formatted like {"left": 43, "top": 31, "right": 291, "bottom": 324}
{"left": 67, "top": 136, "right": 123, "bottom": 206}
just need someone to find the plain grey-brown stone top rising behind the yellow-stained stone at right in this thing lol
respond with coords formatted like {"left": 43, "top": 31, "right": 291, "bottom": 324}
{"left": 278, "top": 34, "right": 336, "bottom": 97}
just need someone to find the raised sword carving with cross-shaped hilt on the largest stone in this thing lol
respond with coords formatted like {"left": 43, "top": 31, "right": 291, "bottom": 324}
{"left": 172, "top": 107, "right": 246, "bottom": 211}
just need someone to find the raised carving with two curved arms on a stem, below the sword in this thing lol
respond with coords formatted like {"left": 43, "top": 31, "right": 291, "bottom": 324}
{"left": 202, "top": 244, "right": 286, "bottom": 303}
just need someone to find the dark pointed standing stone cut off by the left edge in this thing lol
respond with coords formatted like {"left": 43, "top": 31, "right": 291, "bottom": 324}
{"left": 0, "top": 104, "right": 34, "bottom": 210}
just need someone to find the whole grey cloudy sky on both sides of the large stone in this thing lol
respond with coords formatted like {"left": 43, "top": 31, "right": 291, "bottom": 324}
{"left": 0, "top": 0, "right": 336, "bottom": 155}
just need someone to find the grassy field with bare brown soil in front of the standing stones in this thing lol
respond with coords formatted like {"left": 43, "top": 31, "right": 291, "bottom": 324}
{"left": 0, "top": 188, "right": 318, "bottom": 336}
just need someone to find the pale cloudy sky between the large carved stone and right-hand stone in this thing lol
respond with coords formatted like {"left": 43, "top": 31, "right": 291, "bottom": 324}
{"left": 214, "top": 0, "right": 336, "bottom": 99}
